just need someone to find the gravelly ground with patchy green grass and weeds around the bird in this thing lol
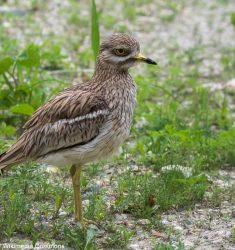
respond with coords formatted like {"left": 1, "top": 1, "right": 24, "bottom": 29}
{"left": 0, "top": 0, "right": 235, "bottom": 250}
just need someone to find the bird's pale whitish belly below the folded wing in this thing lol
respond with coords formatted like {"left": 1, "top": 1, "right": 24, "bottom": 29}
{"left": 39, "top": 119, "right": 130, "bottom": 166}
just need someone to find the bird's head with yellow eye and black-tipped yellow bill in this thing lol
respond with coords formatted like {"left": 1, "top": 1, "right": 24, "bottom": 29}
{"left": 98, "top": 33, "right": 157, "bottom": 69}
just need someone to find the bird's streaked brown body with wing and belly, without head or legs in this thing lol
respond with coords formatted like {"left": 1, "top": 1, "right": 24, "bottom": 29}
{"left": 1, "top": 56, "right": 136, "bottom": 166}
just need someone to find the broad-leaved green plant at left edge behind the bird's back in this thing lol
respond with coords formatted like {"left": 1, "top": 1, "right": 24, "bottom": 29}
{"left": 0, "top": 44, "right": 67, "bottom": 132}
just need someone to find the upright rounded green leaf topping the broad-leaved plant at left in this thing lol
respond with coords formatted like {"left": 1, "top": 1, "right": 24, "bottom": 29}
{"left": 17, "top": 44, "right": 40, "bottom": 68}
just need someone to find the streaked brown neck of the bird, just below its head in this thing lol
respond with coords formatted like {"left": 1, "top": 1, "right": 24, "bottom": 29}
{"left": 92, "top": 57, "right": 128, "bottom": 81}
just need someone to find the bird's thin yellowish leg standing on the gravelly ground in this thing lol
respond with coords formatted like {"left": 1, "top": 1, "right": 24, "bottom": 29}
{"left": 70, "top": 165, "right": 84, "bottom": 225}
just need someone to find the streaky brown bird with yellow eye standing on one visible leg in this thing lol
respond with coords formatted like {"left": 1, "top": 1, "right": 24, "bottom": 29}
{"left": 0, "top": 33, "right": 157, "bottom": 225}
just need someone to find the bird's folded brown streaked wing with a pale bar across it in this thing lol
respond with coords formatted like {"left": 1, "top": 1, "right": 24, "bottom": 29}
{"left": 0, "top": 89, "right": 110, "bottom": 169}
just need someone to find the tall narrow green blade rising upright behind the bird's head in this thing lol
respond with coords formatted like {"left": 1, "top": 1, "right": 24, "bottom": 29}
{"left": 91, "top": 0, "right": 100, "bottom": 60}
